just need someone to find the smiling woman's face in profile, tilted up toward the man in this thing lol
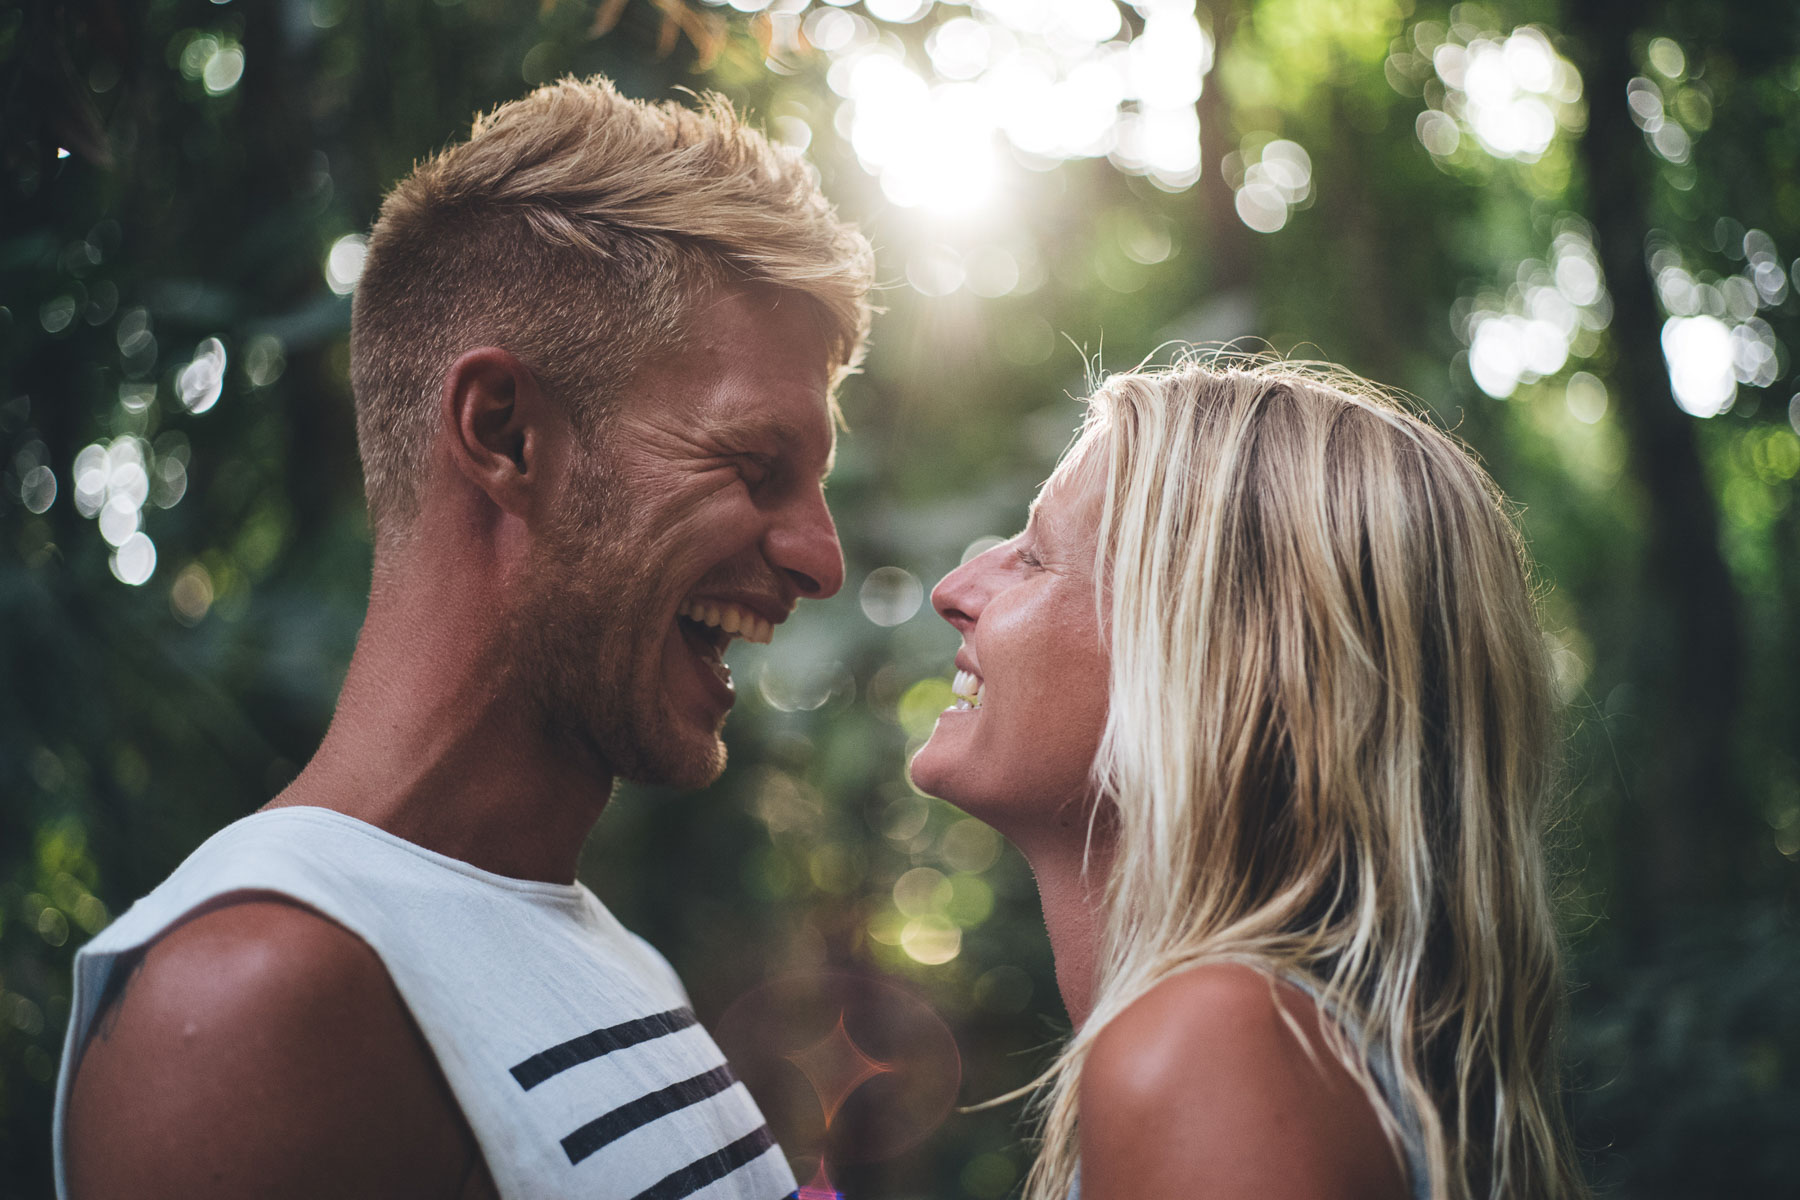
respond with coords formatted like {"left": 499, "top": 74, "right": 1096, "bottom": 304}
{"left": 913, "top": 444, "right": 1107, "bottom": 833}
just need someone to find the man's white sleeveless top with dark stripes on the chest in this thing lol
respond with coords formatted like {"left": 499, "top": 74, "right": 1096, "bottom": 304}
{"left": 56, "top": 808, "right": 796, "bottom": 1200}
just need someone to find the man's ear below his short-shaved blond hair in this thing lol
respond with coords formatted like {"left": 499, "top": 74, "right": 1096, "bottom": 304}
{"left": 439, "top": 345, "right": 560, "bottom": 516}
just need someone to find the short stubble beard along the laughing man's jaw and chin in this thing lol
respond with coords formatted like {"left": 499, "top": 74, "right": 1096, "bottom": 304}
{"left": 513, "top": 453, "right": 725, "bottom": 788}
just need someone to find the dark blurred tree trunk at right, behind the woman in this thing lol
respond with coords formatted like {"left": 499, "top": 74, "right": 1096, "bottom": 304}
{"left": 1570, "top": 0, "right": 1742, "bottom": 936}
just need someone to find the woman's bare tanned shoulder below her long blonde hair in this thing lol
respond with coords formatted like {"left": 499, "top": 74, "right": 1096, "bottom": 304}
{"left": 1080, "top": 963, "right": 1408, "bottom": 1200}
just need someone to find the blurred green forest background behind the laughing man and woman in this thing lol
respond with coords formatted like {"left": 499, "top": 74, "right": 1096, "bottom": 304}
{"left": 0, "top": 0, "right": 1800, "bottom": 1200}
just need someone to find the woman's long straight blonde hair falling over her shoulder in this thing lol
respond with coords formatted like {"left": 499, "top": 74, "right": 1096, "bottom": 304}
{"left": 1026, "top": 360, "right": 1586, "bottom": 1200}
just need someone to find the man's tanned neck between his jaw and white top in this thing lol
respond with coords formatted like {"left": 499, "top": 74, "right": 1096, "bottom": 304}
{"left": 270, "top": 554, "right": 612, "bottom": 883}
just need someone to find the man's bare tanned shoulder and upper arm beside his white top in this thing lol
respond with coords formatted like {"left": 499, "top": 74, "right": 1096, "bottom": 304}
{"left": 67, "top": 898, "right": 491, "bottom": 1200}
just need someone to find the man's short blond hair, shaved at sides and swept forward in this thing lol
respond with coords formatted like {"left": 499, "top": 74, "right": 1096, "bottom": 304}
{"left": 351, "top": 77, "right": 873, "bottom": 547}
